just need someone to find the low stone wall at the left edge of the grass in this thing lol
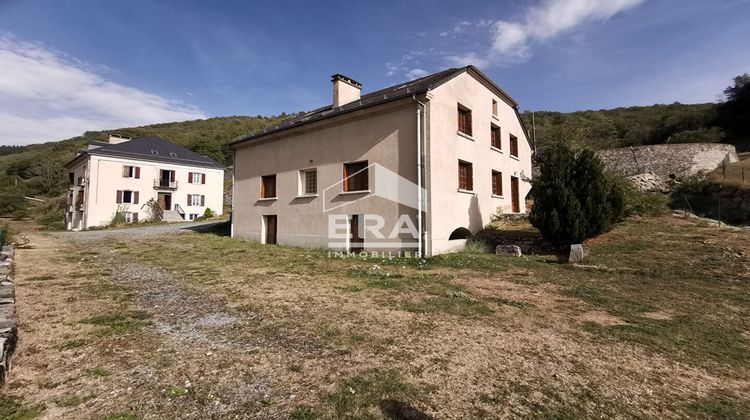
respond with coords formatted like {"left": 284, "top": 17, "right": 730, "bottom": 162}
{"left": 0, "top": 246, "right": 18, "bottom": 386}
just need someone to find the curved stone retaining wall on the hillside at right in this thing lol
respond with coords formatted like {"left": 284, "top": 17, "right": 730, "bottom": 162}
{"left": 597, "top": 143, "right": 739, "bottom": 179}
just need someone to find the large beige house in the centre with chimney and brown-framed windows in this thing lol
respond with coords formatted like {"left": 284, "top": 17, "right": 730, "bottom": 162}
{"left": 232, "top": 66, "right": 532, "bottom": 255}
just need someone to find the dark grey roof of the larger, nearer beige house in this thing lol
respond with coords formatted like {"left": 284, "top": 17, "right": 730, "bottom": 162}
{"left": 230, "top": 66, "right": 518, "bottom": 146}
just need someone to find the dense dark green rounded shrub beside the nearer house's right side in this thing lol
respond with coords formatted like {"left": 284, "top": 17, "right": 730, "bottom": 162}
{"left": 529, "top": 141, "right": 625, "bottom": 246}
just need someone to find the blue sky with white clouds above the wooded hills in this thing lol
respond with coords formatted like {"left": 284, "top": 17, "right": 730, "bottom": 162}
{"left": 0, "top": 0, "right": 750, "bottom": 144}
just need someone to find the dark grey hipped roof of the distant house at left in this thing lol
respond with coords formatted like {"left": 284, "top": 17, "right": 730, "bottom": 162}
{"left": 70, "top": 136, "right": 223, "bottom": 168}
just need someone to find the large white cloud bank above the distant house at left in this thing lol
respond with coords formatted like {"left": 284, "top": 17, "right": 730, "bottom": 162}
{"left": 0, "top": 33, "right": 206, "bottom": 144}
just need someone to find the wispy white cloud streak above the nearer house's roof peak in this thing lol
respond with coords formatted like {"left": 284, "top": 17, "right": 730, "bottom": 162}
{"left": 448, "top": 0, "right": 645, "bottom": 65}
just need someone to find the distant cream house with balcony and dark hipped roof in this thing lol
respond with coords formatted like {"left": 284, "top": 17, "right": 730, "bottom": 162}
{"left": 66, "top": 136, "right": 224, "bottom": 230}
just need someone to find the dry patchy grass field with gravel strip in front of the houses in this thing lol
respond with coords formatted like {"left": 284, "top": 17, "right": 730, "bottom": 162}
{"left": 0, "top": 217, "right": 750, "bottom": 419}
